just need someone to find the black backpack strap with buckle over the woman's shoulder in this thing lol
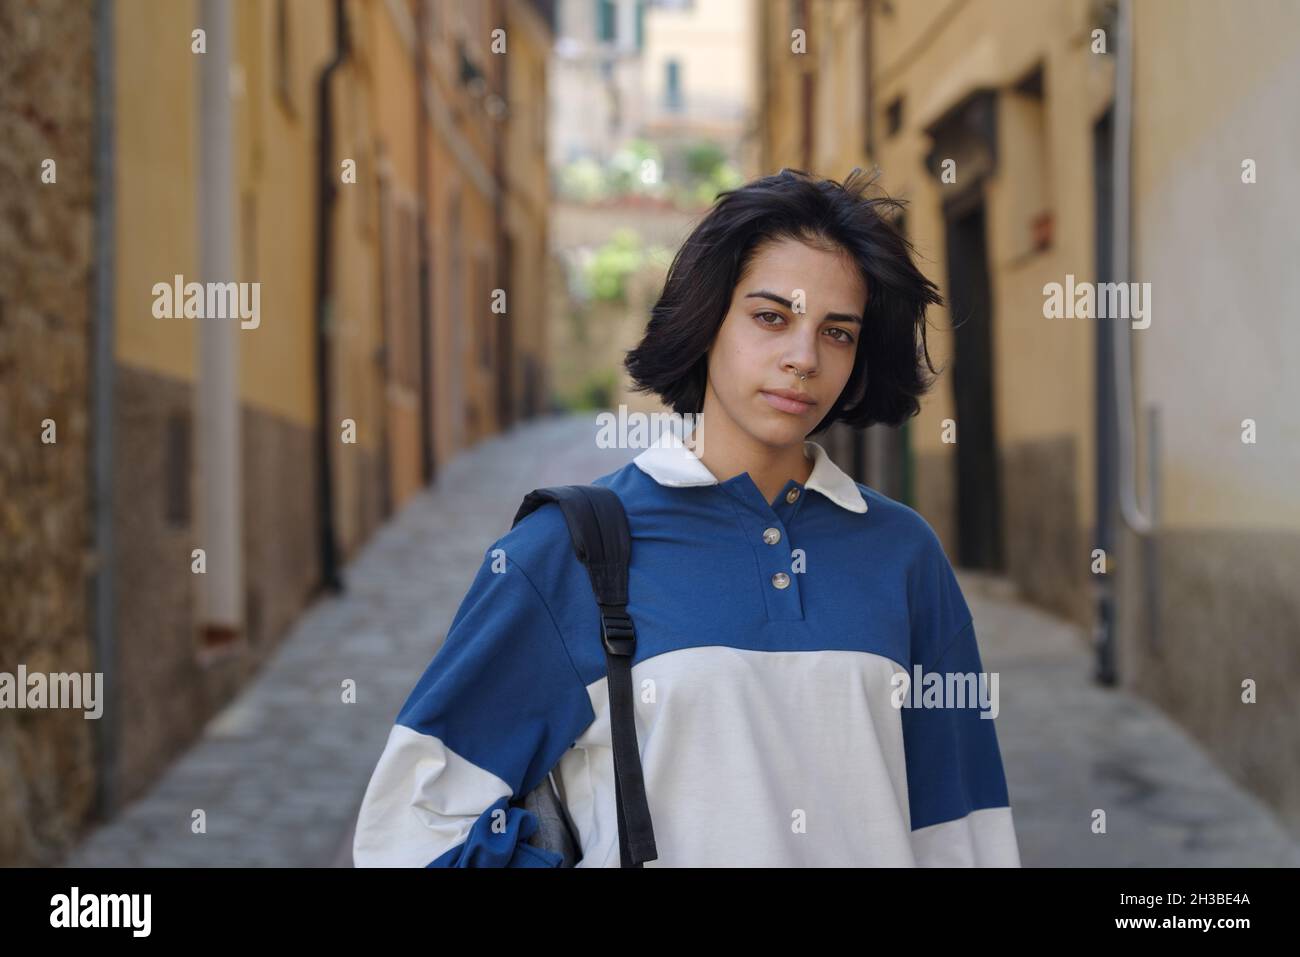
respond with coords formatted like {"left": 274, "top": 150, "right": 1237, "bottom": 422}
{"left": 511, "top": 485, "right": 659, "bottom": 867}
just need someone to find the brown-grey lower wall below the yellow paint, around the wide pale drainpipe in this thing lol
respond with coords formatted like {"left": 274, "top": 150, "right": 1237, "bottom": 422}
{"left": 114, "top": 365, "right": 325, "bottom": 801}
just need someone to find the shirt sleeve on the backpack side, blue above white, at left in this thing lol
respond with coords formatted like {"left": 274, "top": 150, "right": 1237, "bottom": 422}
{"left": 352, "top": 542, "right": 595, "bottom": 867}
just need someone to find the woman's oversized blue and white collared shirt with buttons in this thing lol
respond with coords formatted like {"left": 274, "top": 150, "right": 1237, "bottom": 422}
{"left": 354, "top": 433, "right": 1019, "bottom": 867}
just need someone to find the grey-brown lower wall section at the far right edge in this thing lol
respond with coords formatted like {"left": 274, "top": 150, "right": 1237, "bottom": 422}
{"left": 1117, "top": 529, "right": 1300, "bottom": 837}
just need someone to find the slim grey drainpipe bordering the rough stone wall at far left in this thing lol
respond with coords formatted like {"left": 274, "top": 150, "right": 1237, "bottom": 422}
{"left": 88, "top": 0, "right": 120, "bottom": 820}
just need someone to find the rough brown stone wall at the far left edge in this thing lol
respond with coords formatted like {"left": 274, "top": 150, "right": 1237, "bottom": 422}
{"left": 0, "top": 0, "right": 96, "bottom": 866}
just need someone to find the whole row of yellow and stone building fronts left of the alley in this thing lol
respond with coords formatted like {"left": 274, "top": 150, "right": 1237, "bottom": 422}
{"left": 0, "top": 0, "right": 553, "bottom": 863}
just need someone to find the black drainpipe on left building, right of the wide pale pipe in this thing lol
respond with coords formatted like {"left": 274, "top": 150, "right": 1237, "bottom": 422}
{"left": 316, "top": 0, "right": 347, "bottom": 593}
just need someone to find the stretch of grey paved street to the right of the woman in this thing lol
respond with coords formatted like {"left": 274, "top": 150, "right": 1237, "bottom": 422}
{"left": 958, "top": 573, "right": 1300, "bottom": 867}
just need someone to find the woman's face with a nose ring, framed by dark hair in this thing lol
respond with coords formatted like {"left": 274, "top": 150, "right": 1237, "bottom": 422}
{"left": 703, "top": 239, "right": 867, "bottom": 447}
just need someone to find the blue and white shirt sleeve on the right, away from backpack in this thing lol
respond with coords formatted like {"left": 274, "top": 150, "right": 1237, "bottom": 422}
{"left": 902, "top": 622, "right": 1021, "bottom": 867}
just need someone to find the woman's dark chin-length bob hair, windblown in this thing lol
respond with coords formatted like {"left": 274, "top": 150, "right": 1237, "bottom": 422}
{"left": 624, "top": 168, "right": 944, "bottom": 434}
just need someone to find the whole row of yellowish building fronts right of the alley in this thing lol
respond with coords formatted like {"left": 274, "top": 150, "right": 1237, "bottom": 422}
{"left": 759, "top": 0, "right": 1300, "bottom": 831}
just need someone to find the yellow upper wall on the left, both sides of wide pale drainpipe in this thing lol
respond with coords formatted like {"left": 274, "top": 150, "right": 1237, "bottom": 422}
{"left": 114, "top": 0, "right": 332, "bottom": 425}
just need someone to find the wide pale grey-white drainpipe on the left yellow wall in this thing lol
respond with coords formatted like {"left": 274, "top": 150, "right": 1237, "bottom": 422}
{"left": 195, "top": 0, "right": 243, "bottom": 646}
